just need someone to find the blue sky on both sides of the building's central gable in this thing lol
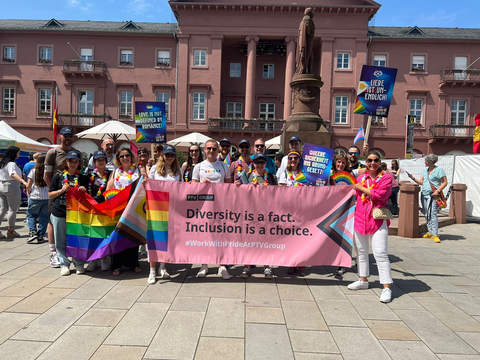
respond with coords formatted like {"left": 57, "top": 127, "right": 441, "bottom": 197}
{"left": 0, "top": 0, "right": 480, "bottom": 28}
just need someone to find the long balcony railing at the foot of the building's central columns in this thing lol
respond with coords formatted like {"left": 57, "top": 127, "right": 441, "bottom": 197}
{"left": 208, "top": 118, "right": 285, "bottom": 132}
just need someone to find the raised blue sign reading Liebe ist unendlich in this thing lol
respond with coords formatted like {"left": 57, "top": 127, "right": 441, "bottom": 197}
{"left": 354, "top": 65, "right": 397, "bottom": 117}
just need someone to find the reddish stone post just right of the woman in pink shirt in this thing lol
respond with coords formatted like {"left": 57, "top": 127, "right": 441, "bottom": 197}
{"left": 398, "top": 181, "right": 420, "bottom": 238}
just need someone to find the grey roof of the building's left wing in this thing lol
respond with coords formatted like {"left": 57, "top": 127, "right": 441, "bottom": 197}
{"left": 0, "top": 19, "right": 178, "bottom": 34}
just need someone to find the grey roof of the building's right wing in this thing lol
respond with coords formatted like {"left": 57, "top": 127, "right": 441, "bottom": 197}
{"left": 368, "top": 26, "right": 480, "bottom": 40}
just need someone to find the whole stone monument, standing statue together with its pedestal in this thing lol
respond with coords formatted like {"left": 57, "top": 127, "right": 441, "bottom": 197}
{"left": 282, "top": 8, "right": 331, "bottom": 152}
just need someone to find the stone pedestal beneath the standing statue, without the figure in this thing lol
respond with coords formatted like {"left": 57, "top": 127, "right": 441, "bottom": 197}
{"left": 281, "top": 74, "right": 332, "bottom": 154}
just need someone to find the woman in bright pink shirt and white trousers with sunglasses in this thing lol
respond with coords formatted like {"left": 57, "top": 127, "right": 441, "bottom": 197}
{"left": 348, "top": 151, "right": 393, "bottom": 303}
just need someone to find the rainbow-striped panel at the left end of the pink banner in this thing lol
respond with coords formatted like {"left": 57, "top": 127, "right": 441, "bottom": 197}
{"left": 146, "top": 190, "right": 170, "bottom": 252}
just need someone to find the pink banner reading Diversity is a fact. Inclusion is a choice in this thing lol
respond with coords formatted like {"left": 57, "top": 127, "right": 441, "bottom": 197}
{"left": 142, "top": 180, "right": 355, "bottom": 267}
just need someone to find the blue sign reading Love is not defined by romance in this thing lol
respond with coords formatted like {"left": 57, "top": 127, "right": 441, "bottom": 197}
{"left": 135, "top": 101, "right": 167, "bottom": 143}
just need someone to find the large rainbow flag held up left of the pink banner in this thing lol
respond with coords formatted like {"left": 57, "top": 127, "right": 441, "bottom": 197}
{"left": 66, "top": 180, "right": 145, "bottom": 261}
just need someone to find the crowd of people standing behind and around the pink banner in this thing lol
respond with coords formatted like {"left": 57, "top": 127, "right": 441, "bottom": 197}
{"left": 0, "top": 127, "right": 447, "bottom": 302}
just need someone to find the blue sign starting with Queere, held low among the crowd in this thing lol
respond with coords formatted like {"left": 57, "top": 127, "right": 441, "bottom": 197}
{"left": 302, "top": 143, "right": 335, "bottom": 186}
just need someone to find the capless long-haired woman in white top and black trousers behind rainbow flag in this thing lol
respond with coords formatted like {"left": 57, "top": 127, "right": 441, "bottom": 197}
{"left": 107, "top": 147, "right": 142, "bottom": 276}
